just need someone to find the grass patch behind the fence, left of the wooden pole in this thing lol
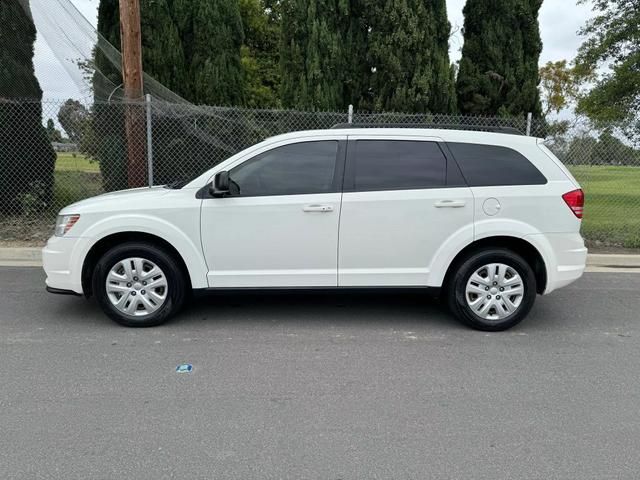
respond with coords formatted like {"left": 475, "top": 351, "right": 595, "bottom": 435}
{"left": 54, "top": 153, "right": 103, "bottom": 208}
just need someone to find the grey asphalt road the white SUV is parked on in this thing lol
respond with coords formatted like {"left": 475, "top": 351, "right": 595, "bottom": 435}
{"left": 0, "top": 268, "right": 640, "bottom": 480}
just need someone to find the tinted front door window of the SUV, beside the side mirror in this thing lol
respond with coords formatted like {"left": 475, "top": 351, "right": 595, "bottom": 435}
{"left": 229, "top": 141, "right": 338, "bottom": 196}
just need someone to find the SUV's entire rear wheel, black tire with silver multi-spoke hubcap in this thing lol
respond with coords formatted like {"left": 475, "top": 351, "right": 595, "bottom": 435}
{"left": 447, "top": 249, "right": 536, "bottom": 331}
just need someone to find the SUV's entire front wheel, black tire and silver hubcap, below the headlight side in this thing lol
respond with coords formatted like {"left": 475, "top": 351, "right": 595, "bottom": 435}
{"left": 93, "top": 242, "right": 186, "bottom": 327}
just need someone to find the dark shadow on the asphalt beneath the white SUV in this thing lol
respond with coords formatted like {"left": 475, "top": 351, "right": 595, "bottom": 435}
{"left": 46, "top": 290, "right": 569, "bottom": 333}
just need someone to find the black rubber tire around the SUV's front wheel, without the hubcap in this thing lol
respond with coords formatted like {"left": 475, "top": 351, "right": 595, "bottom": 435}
{"left": 92, "top": 242, "right": 187, "bottom": 327}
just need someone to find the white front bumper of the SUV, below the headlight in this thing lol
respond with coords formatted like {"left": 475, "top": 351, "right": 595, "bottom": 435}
{"left": 42, "top": 236, "right": 86, "bottom": 295}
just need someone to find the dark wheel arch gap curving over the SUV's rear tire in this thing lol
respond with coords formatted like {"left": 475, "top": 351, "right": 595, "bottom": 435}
{"left": 442, "top": 235, "right": 548, "bottom": 294}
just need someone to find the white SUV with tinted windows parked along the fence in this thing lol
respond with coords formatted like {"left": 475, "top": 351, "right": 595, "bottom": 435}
{"left": 43, "top": 128, "right": 587, "bottom": 331}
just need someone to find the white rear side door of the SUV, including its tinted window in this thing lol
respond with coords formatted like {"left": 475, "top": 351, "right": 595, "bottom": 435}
{"left": 338, "top": 135, "right": 474, "bottom": 286}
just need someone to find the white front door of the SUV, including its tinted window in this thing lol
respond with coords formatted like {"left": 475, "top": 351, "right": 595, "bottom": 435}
{"left": 201, "top": 137, "right": 344, "bottom": 288}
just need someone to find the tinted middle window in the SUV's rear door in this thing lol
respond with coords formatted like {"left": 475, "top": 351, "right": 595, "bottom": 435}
{"left": 352, "top": 140, "right": 447, "bottom": 191}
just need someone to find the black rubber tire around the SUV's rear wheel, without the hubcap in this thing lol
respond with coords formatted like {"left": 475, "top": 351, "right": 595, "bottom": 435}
{"left": 446, "top": 248, "right": 536, "bottom": 332}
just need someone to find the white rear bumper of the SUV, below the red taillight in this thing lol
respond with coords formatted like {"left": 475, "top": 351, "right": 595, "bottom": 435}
{"left": 525, "top": 233, "right": 587, "bottom": 295}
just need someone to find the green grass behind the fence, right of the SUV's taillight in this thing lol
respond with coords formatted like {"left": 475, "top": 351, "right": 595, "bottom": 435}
{"left": 569, "top": 166, "right": 640, "bottom": 248}
